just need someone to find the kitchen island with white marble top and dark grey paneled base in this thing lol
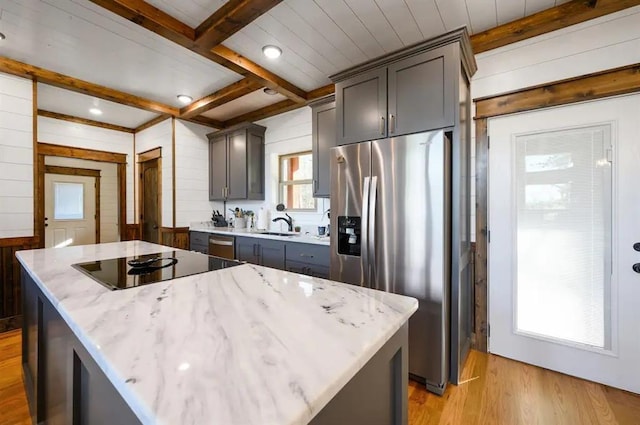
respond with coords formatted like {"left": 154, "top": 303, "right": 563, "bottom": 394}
{"left": 17, "top": 241, "right": 417, "bottom": 425}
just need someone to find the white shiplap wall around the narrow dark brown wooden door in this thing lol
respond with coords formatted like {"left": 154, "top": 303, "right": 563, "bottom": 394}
{"left": 135, "top": 119, "right": 174, "bottom": 227}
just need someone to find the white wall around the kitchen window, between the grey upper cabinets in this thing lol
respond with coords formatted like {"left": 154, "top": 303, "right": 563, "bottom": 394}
{"left": 227, "top": 107, "right": 329, "bottom": 232}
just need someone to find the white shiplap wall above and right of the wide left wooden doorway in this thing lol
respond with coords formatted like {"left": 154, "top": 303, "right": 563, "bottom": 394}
{"left": 38, "top": 117, "right": 134, "bottom": 223}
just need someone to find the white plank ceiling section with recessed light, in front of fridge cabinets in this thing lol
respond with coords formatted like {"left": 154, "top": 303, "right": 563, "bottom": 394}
{"left": 223, "top": 0, "right": 568, "bottom": 90}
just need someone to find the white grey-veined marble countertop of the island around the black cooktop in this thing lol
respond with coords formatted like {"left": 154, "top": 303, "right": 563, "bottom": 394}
{"left": 17, "top": 241, "right": 418, "bottom": 425}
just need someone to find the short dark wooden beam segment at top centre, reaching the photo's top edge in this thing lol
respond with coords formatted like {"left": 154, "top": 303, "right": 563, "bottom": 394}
{"left": 195, "top": 0, "right": 282, "bottom": 49}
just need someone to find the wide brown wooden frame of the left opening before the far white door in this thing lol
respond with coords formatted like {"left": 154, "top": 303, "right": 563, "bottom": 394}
{"left": 34, "top": 143, "right": 127, "bottom": 248}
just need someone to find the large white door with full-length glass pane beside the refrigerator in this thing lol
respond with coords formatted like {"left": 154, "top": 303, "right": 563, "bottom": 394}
{"left": 489, "top": 95, "right": 640, "bottom": 393}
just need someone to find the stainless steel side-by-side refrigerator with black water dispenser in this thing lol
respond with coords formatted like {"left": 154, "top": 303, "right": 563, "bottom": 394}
{"left": 330, "top": 131, "right": 470, "bottom": 394}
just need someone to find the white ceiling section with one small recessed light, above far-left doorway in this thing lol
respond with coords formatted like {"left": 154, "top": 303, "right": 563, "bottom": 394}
{"left": 38, "top": 83, "right": 158, "bottom": 128}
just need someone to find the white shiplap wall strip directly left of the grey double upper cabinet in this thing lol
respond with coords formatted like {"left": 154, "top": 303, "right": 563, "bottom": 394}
{"left": 176, "top": 120, "right": 222, "bottom": 227}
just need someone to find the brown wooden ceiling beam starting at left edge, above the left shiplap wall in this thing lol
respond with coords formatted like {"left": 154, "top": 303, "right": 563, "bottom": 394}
{"left": 0, "top": 56, "right": 179, "bottom": 115}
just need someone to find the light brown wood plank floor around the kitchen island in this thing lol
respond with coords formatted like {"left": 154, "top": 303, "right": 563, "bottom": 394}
{"left": 0, "top": 331, "right": 640, "bottom": 425}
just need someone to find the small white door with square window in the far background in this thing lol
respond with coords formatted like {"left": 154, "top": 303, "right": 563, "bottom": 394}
{"left": 44, "top": 173, "right": 96, "bottom": 248}
